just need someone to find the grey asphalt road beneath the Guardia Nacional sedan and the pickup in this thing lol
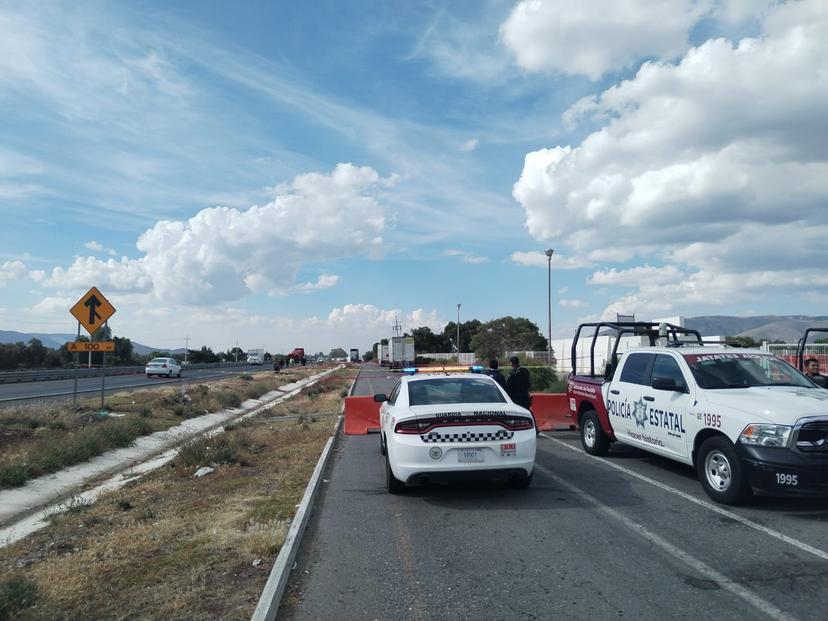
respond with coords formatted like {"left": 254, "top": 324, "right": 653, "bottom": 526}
{"left": 278, "top": 365, "right": 828, "bottom": 621}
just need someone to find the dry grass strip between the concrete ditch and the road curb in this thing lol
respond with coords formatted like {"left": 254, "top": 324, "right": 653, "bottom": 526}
{"left": 0, "top": 373, "right": 353, "bottom": 620}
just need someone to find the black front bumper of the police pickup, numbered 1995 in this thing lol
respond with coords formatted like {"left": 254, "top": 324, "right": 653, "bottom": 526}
{"left": 736, "top": 444, "right": 828, "bottom": 497}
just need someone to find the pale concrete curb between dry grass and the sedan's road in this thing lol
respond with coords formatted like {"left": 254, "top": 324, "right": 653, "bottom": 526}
{"left": 251, "top": 410, "right": 342, "bottom": 621}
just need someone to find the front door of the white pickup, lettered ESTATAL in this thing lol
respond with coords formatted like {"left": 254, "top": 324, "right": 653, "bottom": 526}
{"left": 643, "top": 354, "right": 692, "bottom": 463}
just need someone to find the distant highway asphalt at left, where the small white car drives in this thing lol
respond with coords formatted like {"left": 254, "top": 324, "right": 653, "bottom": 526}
{"left": 0, "top": 365, "right": 272, "bottom": 406}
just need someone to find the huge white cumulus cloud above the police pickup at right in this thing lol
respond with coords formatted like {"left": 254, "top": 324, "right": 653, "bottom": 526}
{"left": 513, "top": 0, "right": 828, "bottom": 315}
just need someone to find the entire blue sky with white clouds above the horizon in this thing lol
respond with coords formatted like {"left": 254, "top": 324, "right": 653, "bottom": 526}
{"left": 0, "top": 0, "right": 828, "bottom": 351}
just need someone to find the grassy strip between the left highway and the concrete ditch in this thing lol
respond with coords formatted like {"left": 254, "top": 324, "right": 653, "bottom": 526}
{"left": 0, "top": 368, "right": 319, "bottom": 489}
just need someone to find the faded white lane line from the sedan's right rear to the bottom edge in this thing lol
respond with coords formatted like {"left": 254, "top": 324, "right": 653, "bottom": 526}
{"left": 535, "top": 464, "right": 794, "bottom": 620}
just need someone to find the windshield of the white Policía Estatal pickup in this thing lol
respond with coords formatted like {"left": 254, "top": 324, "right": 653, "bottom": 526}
{"left": 684, "top": 353, "right": 817, "bottom": 389}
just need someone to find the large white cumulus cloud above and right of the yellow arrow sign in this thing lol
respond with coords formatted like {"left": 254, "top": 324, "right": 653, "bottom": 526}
{"left": 45, "top": 164, "right": 393, "bottom": 304}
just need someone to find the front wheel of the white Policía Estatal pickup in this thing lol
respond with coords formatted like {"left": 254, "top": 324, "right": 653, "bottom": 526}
{"left": 696, "top": 436, "right": 751, "bottom": 505}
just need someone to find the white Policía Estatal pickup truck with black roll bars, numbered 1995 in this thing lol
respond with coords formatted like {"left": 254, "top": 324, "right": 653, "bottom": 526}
{"left": 567, "top": 322, "right": 828, "bottom": 504}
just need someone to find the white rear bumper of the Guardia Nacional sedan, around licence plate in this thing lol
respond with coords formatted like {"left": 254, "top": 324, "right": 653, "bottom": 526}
{"left": 388, "top": 429, "right": 537, "bottom": 483}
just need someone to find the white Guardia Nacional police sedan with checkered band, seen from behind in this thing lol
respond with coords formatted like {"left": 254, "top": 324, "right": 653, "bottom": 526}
{"left": 374, "top": 371, "right": 536, "bottom": 494}
